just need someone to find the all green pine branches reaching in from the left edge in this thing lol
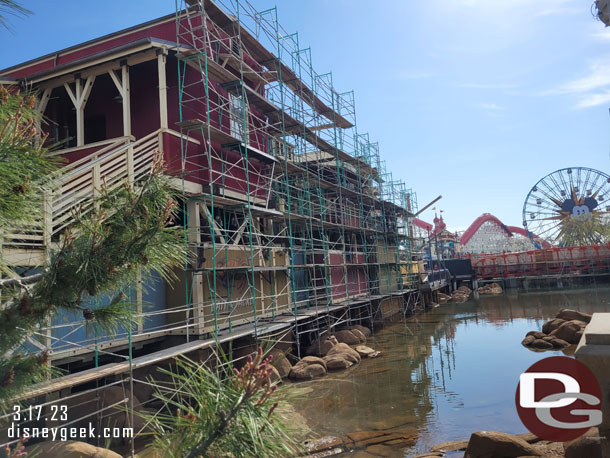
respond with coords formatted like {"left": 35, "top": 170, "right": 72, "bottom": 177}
{"left": 0, "top": 87, "right": 186, "bottom": 403}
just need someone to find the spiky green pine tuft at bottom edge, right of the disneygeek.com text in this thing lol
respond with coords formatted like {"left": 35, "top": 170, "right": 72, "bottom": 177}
{"left": 140, "top": 348, "right": 299, "bottom": 458}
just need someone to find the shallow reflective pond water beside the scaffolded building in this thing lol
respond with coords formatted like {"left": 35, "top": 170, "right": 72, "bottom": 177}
{"left": 282, "top": 287, "right": 610, "bottom": 456}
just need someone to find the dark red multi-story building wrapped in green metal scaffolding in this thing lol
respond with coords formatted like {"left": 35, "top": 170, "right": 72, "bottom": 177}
{"left": 0, "top": 0, "right": 417, "bottom": 450}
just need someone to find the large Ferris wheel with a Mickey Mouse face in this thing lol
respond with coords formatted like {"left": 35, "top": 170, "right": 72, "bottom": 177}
{"left": 523, "top": 167, "right": 610, "bottom": 248}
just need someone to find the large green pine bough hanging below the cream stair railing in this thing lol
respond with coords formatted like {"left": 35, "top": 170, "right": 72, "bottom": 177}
{"left": 0, "top": 168, "right": 186, "bottom": 399}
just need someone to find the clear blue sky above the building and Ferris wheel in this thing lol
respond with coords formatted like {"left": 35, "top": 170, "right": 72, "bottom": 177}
{"left": 0, "top": 0, "right": 610, "bottom": 230}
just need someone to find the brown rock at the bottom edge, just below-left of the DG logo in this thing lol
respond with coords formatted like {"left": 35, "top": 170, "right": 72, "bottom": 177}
{"left": 464, "top": 431, "right": 540, "bottom": 458}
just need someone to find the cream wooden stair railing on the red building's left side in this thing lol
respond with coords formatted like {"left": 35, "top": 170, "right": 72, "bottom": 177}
{"left": 1, "top": 130, "right": 162, "bottom": 250}
